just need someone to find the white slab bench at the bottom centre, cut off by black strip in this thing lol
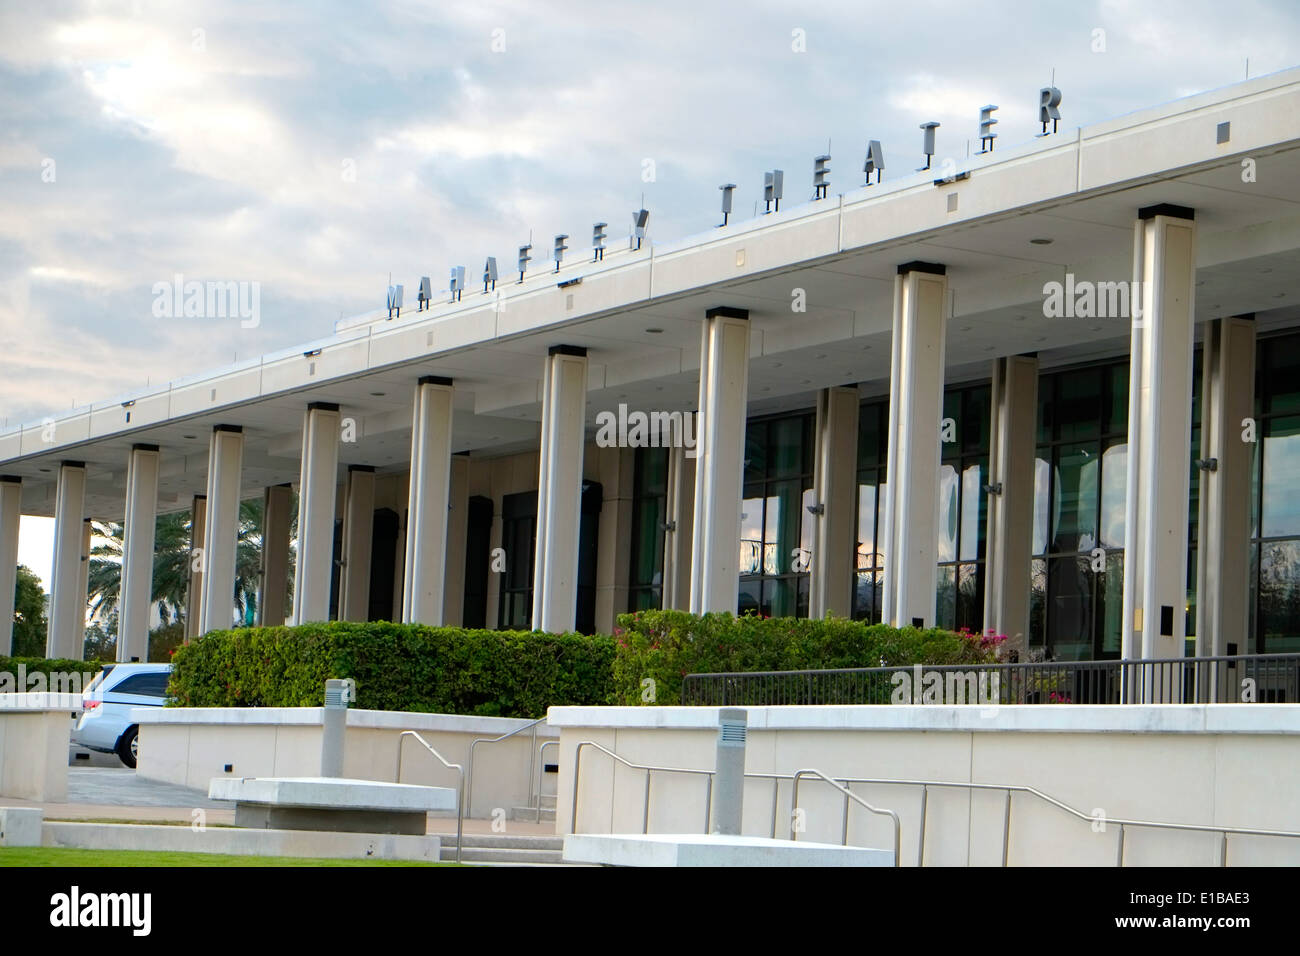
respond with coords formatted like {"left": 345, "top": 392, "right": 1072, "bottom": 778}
{"left": 564, "top": 834, "right": 894, "bottom": 866}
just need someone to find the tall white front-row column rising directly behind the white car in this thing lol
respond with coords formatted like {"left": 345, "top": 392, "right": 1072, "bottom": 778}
{"left": 117, "top": 445, "right": 159, "bottom": 662}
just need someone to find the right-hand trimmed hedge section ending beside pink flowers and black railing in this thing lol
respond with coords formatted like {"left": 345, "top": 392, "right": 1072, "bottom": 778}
{"left": 614, "top": 610, "right": 998, "bottom": 705}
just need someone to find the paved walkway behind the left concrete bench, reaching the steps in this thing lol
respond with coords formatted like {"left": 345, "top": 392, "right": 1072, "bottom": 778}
{"left": 0, "top": 766, "right": 555, "bottom": 836}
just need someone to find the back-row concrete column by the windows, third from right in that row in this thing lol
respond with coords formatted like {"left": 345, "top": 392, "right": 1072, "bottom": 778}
{"left": 809, "top": 386, "right": 859, "bottom": 618}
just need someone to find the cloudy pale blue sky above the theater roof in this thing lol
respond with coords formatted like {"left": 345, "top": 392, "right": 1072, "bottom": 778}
{"left": 0, "top": 0, "right": 1300, "bottom": 575}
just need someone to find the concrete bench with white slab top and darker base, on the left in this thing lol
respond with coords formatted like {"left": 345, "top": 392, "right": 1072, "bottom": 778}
{"left": 208, "top": 777, "right": 456, "bottom": 835}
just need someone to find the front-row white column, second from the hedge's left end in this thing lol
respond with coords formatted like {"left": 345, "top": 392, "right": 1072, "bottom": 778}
{"left": 294, "top": 402, "right": 339, "bottom": 624}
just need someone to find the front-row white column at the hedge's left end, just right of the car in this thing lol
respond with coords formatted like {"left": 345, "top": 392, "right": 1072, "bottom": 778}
{"left": 199, "top": 425, "right": 243, "bottom": 635}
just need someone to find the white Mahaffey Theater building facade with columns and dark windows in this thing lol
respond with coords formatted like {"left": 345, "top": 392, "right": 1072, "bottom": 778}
{"left": 0, "top": 70, "right": 1300, "bottom": 661}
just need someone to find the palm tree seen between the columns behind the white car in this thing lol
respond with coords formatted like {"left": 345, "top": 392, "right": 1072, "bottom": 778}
{"left": 88, "top": 496, "right": 298, "bottom": 627}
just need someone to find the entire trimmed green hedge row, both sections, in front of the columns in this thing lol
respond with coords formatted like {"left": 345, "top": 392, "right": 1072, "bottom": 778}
{"left": 159, "top": 611, "right": 996, "bottom": 717}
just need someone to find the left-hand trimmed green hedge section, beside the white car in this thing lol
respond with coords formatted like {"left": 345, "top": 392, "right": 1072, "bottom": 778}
{"left": 169, "top": 622, "right": 614, "bottom": 717}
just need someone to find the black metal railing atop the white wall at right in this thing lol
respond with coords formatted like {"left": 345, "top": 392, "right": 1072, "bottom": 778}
{"left": 681, "top": 654, "right": 1300, "bottom": 706}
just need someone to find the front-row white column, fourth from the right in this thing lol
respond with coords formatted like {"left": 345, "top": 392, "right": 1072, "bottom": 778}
{"left": 533, "top": 345, "right": 586, "bottom": 633}
